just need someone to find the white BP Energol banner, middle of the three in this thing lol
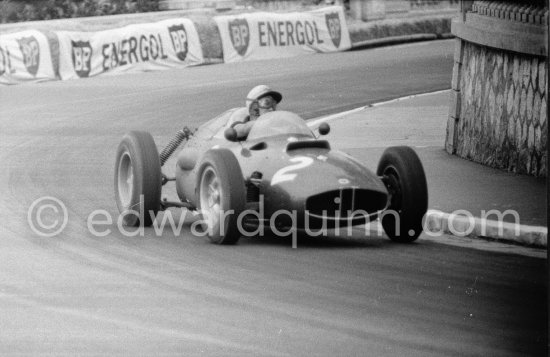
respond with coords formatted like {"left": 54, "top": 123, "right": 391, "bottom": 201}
{"left": 56, "top": 19, "right": 204, "bottom": 80}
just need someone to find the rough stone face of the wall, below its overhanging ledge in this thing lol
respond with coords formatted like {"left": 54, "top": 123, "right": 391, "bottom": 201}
{"left": 456, "top": 43, "right": 547, "bottom": 175}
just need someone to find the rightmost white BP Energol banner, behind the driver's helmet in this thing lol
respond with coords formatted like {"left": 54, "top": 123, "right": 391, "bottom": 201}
{"left": 214, "top": 6, "right": 351, "bottom": 62}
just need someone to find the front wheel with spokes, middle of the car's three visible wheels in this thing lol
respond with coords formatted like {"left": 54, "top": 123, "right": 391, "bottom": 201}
{"left": 196, "top": 149, "right": 246, "bottom": 244}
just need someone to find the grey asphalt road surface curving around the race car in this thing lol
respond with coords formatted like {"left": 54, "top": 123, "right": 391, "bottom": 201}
{"left": 0, "top": 41, "right": 547, "bottom": 356}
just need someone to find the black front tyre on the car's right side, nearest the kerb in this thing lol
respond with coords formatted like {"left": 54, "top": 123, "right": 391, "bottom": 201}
{"left": 376, "top": 146, "right": 428, "bottom": 243}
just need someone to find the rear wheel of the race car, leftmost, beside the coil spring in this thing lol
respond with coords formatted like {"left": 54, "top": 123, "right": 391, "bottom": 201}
{"left": 115, "top": 131, "right": 162, "bottom": 227}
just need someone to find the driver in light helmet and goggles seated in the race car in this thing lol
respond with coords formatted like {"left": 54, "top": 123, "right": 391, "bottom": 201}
{"left": 233, "top": 84, "right": 283, "bottom": 140}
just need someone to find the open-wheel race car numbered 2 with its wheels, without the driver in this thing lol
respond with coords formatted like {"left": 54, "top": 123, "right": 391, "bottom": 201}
{"left": 114, "top": 108, "right": 428, "bottom": 244}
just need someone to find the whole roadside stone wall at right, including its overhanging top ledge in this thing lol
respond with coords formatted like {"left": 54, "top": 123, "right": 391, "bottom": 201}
{"left": 446, "top": 1, "right": 548, "bottom": 176}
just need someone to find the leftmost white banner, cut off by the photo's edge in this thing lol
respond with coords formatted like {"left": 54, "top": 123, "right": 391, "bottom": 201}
{"left": 0, "top": 30, "right": 56, "bottom": 84}
